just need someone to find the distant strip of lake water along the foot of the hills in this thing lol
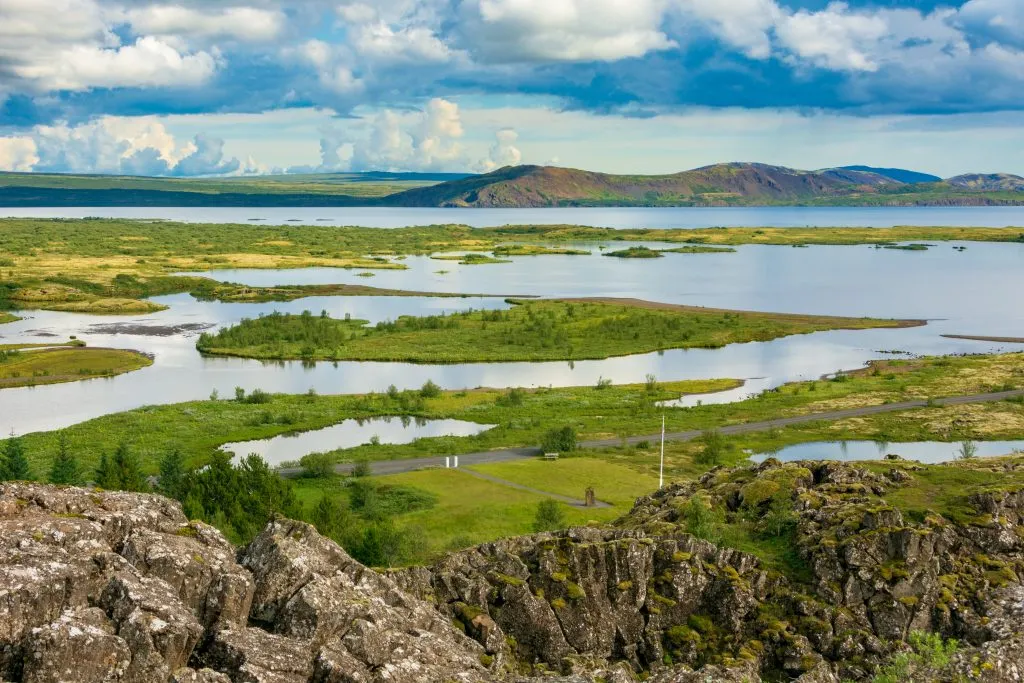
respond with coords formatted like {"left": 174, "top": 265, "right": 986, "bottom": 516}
{"left": 0, "top": 207, "right": 1024, "bottom": 228}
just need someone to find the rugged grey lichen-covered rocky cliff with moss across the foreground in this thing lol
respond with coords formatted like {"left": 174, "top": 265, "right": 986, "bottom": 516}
{"left": 0, "top": 462, "right": 1024, "bottom": 683}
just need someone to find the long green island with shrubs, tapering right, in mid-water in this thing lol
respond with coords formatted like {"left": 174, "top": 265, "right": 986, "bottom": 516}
{"left": 197, "top": 299, "right": 916, "bottom": 364}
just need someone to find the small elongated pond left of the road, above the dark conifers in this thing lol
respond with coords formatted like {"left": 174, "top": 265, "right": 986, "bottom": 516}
{"left": 220, "top": 418, "right": 494, "bottom": 466}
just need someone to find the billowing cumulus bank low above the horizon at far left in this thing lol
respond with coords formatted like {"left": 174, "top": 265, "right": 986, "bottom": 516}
{"left": 0, "top": 117, "right": 245, "bottom": 176}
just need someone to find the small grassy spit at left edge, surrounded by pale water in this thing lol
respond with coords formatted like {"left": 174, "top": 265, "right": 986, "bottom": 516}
{"left": 0, "top": 345, "right": 153, "bottom": 389}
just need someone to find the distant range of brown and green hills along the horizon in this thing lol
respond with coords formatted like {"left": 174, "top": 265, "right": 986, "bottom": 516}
{"left": 0, "top": 163, "right": 1024, "bottom": 208}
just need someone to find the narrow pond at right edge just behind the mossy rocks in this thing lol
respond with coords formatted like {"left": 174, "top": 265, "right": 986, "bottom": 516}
{"left": 751, "top": 441, "right": 1024, "bottom": 465}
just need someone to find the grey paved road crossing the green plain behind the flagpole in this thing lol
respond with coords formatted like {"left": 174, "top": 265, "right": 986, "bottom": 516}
{"left": 280, "top": 389, "right": 1024, "bottom": 479}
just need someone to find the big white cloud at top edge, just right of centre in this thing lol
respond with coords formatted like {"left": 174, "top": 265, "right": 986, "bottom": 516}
{"left": 460, "top": 0, "right": 676, "bottom": 62}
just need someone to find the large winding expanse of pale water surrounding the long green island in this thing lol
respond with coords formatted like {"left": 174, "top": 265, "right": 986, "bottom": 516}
{"left": 0, "top": 219, "right": 1024, "bottom": 434}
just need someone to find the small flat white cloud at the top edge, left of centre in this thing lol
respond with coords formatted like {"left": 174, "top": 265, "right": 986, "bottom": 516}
{"left": 125, "top": 5, "right": 286, "bottom": 41}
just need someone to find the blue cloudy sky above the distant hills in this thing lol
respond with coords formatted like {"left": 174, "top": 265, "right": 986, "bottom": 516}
{"left": 0, "top": 0, "right": 1024, "bottom": 177}
